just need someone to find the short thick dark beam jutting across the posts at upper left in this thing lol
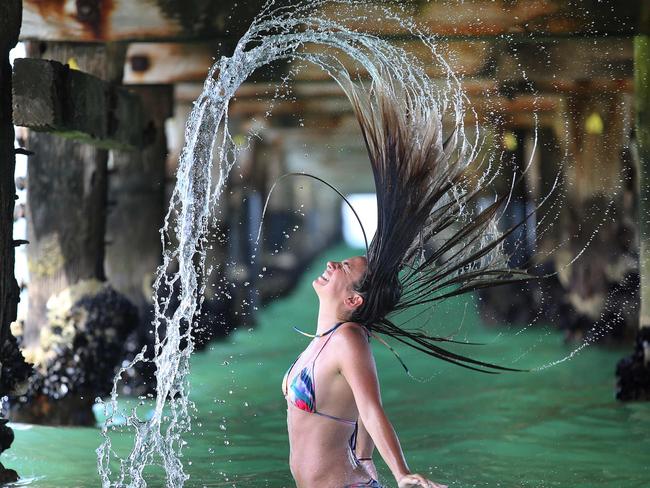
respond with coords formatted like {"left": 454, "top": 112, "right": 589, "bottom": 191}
{"left": 13, "top": 58, "right": 142, "bottom": 148}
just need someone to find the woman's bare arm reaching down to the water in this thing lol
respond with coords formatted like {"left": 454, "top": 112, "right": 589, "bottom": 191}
{"left": 335, "top": 326, "right": 444, "bottom": 488}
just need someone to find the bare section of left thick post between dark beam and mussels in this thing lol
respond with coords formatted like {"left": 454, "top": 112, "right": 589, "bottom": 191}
{"left": 23, "top": 131, "right": 108, "bottom": 348}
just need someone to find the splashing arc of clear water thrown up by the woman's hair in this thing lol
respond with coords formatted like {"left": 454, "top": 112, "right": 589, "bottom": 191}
{"left": 97, "top": 0, "right": 520, "bottom": 488}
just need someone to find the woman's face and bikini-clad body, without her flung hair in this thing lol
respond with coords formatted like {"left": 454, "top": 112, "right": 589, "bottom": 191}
{"left": 283, "top": 256, "right": 446, "bottom": 488}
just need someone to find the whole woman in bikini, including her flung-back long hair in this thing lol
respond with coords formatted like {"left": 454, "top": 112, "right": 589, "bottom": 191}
{"left": 283, "top": 73, "right": 529, "bottom": 488}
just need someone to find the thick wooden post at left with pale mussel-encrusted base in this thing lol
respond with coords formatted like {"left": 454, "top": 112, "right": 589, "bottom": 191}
{"left": 12, "top": 43, "right": 141, "bottom": 425}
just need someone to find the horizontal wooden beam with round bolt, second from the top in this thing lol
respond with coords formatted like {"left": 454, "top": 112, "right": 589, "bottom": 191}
{"left": 124, "top": 38, "right": 633, "bottom": 84}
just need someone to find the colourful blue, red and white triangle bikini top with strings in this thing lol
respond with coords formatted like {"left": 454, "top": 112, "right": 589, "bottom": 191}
{"left": 283, "top": 322, "right": 357, "bottom": 426}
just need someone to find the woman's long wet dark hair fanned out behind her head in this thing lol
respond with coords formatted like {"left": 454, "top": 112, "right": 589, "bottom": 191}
{"left": 342, "top": 77, "right": 530, "bottom": 373}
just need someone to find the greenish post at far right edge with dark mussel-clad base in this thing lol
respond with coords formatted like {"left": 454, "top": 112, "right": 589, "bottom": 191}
{"left": 616, "top": 7, "right": 650, "bottom": 401}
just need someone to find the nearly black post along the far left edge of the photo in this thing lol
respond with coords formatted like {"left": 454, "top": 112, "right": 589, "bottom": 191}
{"left": 0, "top": 0, "right": 30, "bottom": 484}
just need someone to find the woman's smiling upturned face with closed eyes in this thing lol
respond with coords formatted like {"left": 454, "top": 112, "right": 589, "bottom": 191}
{"left": 312, "top": 256, "right": 367, "bottom": 301}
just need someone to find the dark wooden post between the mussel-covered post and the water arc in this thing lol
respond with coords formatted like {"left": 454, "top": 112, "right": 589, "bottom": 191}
{"left": 105, "top": 85, "right": 173, "bottom": 312}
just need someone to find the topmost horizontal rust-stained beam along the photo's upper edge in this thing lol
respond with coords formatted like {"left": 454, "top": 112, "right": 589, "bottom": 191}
{"left": 21, "top": 0, "right": 641, "bottom": 41}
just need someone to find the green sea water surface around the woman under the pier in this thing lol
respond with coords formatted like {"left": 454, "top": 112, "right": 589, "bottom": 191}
{"left": 2, "top": 247, "right": 650, "bottom": 488}
